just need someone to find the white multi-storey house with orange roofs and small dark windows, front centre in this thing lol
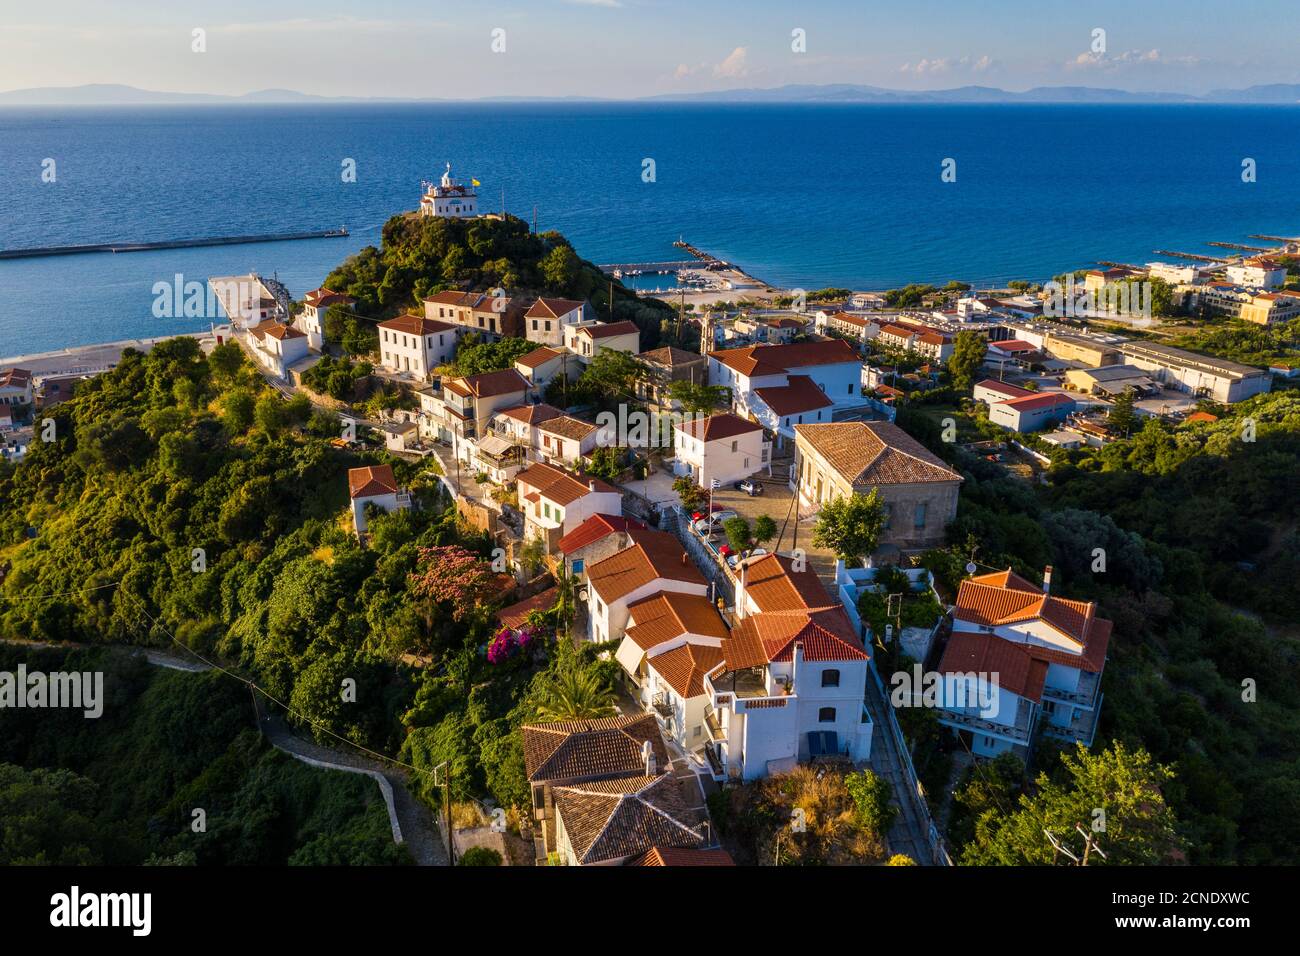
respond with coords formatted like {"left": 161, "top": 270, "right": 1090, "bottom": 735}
{"left": 703, "top": 554, "right": 872, "bottom": 780}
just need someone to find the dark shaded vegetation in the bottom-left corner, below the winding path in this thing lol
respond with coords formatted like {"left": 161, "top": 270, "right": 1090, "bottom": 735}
{"left": 0, "top": 646, "right": 410, "bottom": 865}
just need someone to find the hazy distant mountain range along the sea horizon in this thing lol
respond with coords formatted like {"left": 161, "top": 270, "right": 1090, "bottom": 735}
{"left": 0, "top": 83, "right": 1300, "bottom": 107}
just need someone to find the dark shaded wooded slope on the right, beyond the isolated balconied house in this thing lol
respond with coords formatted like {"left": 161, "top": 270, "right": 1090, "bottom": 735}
{"left": 900, "top": 392, "right": 1300, "bottom": 864}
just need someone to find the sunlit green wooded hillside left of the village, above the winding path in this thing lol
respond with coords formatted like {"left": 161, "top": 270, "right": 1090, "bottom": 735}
{"left": 0, "top": 338, "right": 618, "bottom": 848}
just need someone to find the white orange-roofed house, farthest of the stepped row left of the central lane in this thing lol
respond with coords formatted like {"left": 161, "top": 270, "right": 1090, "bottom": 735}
{"left": 586, "top": 531, "right": 709, "bottom": 641}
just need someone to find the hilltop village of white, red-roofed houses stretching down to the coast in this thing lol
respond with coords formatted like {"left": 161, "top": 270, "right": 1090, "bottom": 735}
{"left": 0, "top": 165, "right": 1300, "bottom": 865}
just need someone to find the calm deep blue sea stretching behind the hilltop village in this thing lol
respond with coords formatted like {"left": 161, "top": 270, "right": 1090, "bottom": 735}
{"left": 0, "top": 104, "right": 1300, "bottom": 356}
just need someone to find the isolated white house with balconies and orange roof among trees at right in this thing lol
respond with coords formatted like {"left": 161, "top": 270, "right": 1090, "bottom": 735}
{"left": 939, "top": 567, "right": 1113, "bottom": 757}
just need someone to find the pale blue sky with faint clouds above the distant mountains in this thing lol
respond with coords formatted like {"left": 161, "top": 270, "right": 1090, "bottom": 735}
{"left": 0, "top": 0, "right": 1300, "bottom": 98}
